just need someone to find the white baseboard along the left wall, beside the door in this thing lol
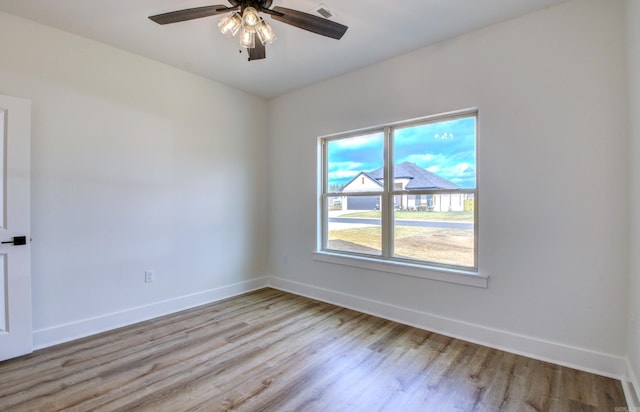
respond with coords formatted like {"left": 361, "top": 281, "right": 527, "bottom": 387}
{"left": 33, "top": 277, "right": 268, "bottom": 350}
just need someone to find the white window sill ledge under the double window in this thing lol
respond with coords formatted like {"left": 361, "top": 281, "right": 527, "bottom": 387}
{"left": 313, "top": 251, "right": 489, "bottom": 288}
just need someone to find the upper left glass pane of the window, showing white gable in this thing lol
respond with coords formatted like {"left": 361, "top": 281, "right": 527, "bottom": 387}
{"left": 327, "top": 132, "right": 384, "bottom": 193}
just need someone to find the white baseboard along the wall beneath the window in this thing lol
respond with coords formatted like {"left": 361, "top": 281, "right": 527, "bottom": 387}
{"left": 268, "top": 277, "right": 625, "bottom": 379}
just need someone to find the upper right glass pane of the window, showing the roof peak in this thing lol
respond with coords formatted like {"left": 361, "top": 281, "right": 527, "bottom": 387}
{"left": 393, "top": 117, "right": 476, "bottom": 190}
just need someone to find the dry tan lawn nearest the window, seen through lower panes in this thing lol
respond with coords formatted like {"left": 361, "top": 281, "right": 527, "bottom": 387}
{"left": 329, "top": 225, "right": 474, "bottom": 266}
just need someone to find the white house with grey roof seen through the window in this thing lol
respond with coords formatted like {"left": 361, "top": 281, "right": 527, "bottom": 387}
{"left": 341, "top": 162, "right": 473, "bottom": 212}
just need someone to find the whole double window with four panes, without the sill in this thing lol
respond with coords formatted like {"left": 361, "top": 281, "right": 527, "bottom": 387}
{"left": 319, "top": 111, "right": 478, "bottom": 272}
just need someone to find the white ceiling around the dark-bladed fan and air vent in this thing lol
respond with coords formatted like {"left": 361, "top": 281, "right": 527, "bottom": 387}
{"left": 0, "top": 0, "right": 566, "bottom": 97}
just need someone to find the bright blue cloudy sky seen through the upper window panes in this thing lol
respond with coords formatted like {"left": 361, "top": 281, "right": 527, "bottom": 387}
{"left": 328, "top": 117, "right": 476, "bottom": 188}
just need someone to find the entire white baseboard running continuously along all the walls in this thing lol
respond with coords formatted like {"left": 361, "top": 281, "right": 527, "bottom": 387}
{"left": 33, "top": 277, "right": 628, "bottom": 384}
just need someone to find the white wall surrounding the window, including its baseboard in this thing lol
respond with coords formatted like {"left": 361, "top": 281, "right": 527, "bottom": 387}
{"left": 269, "top": 0, "right": 637, "bottom": 375}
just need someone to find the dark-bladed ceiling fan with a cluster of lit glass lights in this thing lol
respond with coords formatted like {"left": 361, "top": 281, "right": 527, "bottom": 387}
{"left": 149, "top": 0, "right": 348, "bottom": 61}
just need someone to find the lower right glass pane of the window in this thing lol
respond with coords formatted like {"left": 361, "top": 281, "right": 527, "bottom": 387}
{"left": 393, "top": 193, "right": 475, "bottom": 267}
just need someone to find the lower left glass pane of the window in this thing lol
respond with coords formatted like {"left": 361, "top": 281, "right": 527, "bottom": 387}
{"left": 327, "top": 196, "right": 382, "bottom": 256}
